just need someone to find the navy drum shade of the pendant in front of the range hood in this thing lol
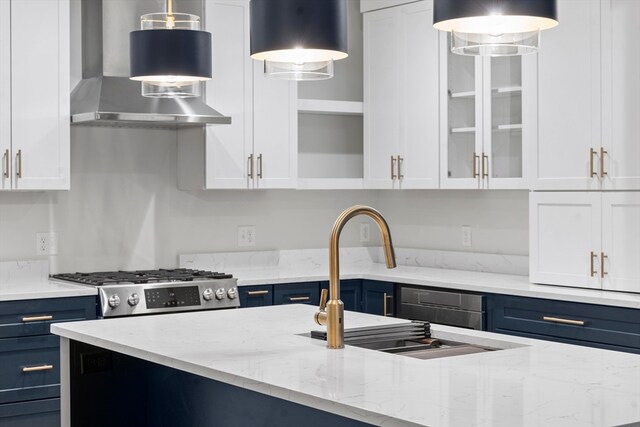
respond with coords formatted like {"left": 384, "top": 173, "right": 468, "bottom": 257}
{"left": 129, "top": 29, "right": 212, "bottom": 80}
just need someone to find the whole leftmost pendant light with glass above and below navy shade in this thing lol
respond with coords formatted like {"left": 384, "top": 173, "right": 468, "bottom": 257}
{"left": 129, "top": 0, "right": 211, "bottom": 98}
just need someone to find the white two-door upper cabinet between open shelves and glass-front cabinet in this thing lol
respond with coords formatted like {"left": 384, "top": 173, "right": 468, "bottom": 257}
{"left": 364, "top": 1, "right": 439, "bottom": 189}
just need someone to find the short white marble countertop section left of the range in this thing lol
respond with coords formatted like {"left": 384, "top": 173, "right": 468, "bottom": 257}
{"left": 0, "top": 281, "right": 98, "bottom": 301}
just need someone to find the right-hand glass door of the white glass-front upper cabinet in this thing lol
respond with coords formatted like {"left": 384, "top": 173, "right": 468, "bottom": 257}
{"left": 481, "top": 56, "right": 524, "bottom": 188}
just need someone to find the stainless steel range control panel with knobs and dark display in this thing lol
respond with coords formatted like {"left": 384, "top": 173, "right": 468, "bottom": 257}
{"left": 99, "top": 278, "right": 240, "bottom": 317}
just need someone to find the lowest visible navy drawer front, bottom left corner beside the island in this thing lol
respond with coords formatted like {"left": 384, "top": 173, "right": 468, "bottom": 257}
{"left": 0, "top": 399, "right": 60, "bottom": 427}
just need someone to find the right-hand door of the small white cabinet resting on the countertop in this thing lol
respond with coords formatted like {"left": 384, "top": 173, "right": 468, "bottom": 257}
{"left": 601, "top": 192, "right": 640, "bottom": 292}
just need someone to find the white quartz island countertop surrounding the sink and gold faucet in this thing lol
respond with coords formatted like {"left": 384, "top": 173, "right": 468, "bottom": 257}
{"left": 51, "top": 305, "right": 640, "bottom": 427}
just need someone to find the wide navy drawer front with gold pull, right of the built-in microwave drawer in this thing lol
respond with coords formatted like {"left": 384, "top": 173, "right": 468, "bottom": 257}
{"left": 488, "top": 295, "right": 640, "bottom": 351}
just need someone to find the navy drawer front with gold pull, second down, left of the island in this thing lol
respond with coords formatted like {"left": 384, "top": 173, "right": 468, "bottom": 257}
{"left": 0, "top": 335, "right": 60, "bottom": 403}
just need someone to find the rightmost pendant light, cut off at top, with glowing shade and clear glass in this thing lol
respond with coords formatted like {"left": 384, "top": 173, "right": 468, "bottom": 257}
{"left": 433, "top": 0, "right": 558, "bottom": 56}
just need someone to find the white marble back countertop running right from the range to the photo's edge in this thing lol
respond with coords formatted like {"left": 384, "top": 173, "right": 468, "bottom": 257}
{"left": 233, "top": 263, "right": 640, "bottom": 309}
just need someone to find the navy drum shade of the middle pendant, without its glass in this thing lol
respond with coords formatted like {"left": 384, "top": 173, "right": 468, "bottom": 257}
{"left": 251, "top": 0, "right": 348, "bottom": 57}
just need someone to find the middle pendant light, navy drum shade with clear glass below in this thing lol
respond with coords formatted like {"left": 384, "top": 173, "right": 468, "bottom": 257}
{"left": 251, "top": 0, "right": 348, "bottom": 81}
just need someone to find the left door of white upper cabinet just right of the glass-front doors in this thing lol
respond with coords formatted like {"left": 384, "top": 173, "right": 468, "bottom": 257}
{"left": 531, "top": 0, "right": 604, "bottom": 190}
